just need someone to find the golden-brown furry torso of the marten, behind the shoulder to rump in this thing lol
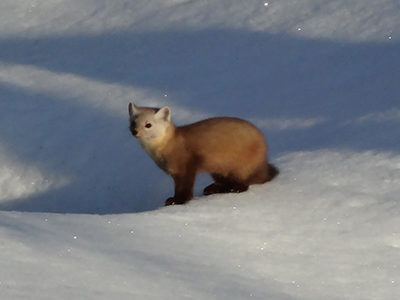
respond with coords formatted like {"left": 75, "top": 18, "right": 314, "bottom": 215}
{"left": 177, "top": 117, "right": 267, "bottom": 179}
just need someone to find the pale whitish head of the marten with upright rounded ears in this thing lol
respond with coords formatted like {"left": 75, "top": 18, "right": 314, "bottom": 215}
{"left": 128, "top": 103, "right": 172, "bottom": 143}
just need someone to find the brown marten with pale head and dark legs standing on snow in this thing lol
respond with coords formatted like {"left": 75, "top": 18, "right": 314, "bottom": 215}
{"left": 128, "top": 103, "right": 279, "bottom": 205}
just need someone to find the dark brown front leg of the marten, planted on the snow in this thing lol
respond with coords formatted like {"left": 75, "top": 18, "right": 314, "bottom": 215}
{"left": 165, "top": 170, "right": 196, "bottom": 206}
